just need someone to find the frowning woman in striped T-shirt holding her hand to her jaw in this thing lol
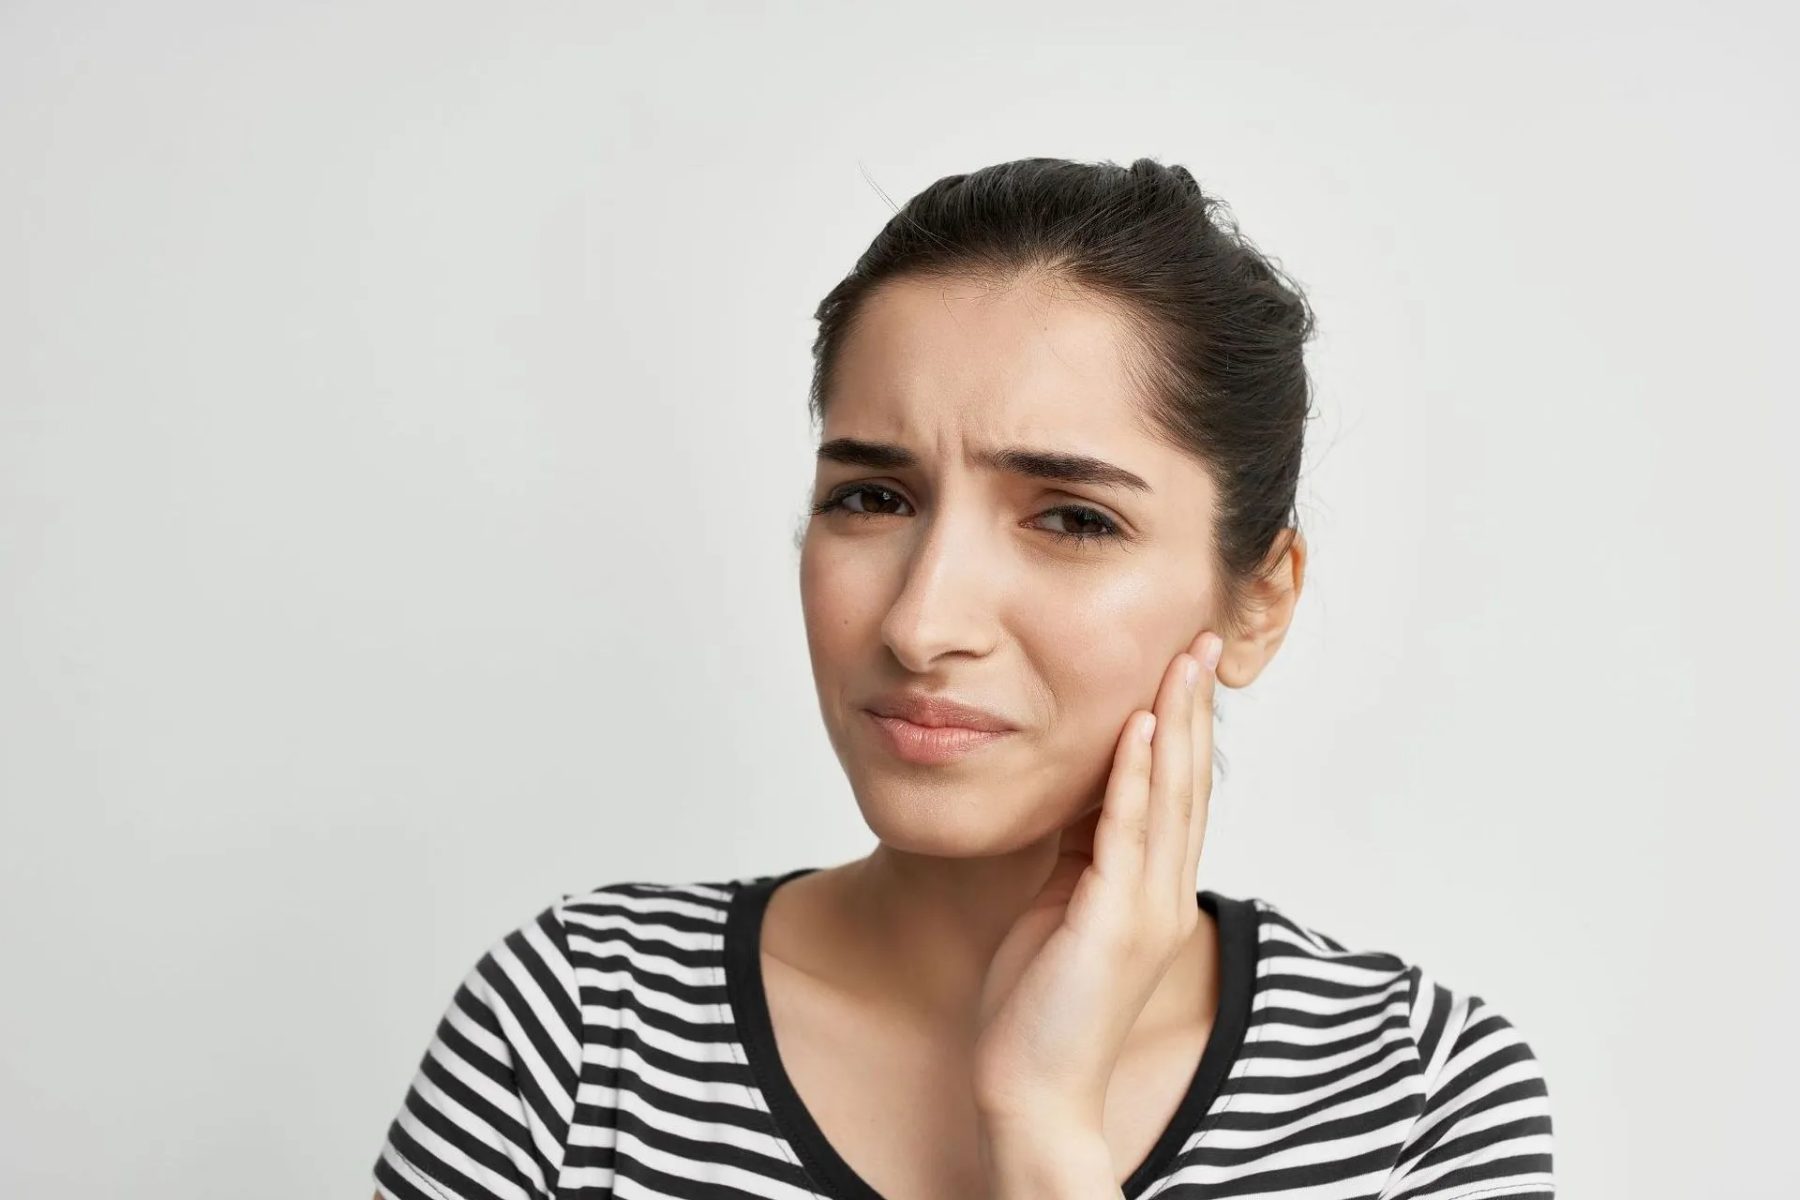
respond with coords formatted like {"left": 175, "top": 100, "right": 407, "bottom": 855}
{"left": 374, "top": 158, "right": 1553, "bottom": 1200}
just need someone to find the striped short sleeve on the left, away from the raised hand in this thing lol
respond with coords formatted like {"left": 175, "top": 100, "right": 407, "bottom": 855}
{"left": 374, "top": 905, "right": 581, "bottom": 1200}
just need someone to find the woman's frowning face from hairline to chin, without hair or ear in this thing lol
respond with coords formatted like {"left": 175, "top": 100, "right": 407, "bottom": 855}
{"left": 801, "top": 281, "right": 1215, "bottom": 856}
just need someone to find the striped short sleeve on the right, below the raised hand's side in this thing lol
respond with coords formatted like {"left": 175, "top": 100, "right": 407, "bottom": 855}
{"left": 1381, "top": 966, "right": 1555, "bottom": 1200}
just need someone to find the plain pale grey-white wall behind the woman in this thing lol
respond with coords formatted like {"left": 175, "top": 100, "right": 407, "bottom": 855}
{"left": 0, "top": 0, "right": 1800, "bottom": 1200}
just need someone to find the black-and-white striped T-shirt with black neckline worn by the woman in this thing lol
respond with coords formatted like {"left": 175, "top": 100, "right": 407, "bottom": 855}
{"left": 374, "top": 867, "right": 1555, "bottom": 1200}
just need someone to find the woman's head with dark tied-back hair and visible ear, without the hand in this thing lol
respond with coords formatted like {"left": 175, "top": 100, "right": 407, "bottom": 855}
{"left": 801, "top": 158, "right": 1312, "bottom": 856}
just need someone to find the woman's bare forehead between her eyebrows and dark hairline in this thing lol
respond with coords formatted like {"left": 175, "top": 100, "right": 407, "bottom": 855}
{"left": 824, "top": 277, "right": 1154, "bottom": 453}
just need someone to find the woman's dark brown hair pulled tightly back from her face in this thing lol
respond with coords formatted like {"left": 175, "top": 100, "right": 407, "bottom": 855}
{"left": 810, "top": 158, "right": 1312, "bottom": 633}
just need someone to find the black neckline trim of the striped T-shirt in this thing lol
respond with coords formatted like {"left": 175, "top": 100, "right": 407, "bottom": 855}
{"left": 724, "top": 867, "right": 1258, "bottom": 1200}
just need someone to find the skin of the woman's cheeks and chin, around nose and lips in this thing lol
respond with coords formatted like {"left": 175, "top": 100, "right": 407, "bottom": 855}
{"left": 801, "top": 518, "right": 1201, "bottom": 856}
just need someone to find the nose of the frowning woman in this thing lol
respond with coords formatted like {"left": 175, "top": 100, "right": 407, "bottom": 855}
{"left": 882, "top": 509, "right": 1004, "bottom": 675}
